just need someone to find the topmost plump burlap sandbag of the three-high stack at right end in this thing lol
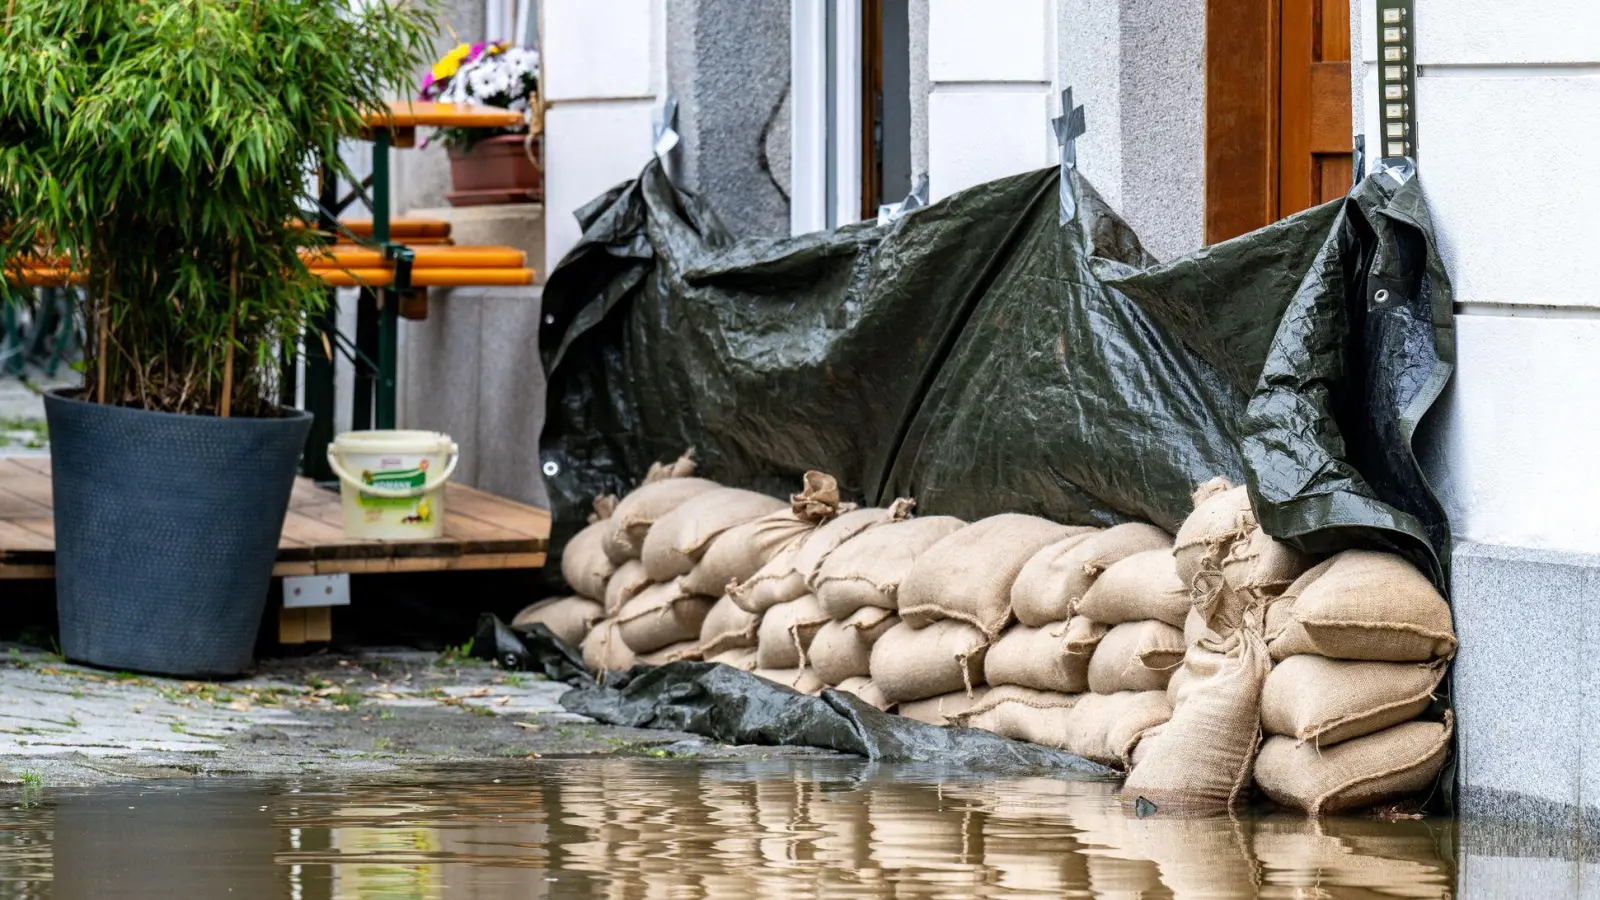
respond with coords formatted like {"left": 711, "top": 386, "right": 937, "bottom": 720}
{"left": 1267, "top": 549, "right": 1456, "bottom": 663}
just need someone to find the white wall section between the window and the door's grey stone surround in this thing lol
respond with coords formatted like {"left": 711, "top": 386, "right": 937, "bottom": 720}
{"left": 928, "top": 0, "right": 1056, "bottom": 200}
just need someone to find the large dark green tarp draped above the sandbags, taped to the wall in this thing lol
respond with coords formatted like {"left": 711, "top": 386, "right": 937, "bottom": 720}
{"left": 541, "top": 162, "right": 1454, "bottom": 589}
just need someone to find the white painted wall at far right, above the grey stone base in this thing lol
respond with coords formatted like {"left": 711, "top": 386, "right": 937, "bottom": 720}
{"left": 1352, "top": 0, "right": 1600, "bottom": 552}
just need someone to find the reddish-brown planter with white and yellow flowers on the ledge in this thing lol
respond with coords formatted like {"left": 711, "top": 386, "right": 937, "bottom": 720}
{"left": 422, "top": 43, "right": 544, "bottom": 207}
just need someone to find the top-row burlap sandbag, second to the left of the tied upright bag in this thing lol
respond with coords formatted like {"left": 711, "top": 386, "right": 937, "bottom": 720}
{"left": 1011, "top": 522, "right": 1173, "bottom": 625}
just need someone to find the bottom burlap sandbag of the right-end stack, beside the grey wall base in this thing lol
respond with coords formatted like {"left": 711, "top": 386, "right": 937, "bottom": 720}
{"left": 1256, "top": 713, "right": 1453, "bottom": 815}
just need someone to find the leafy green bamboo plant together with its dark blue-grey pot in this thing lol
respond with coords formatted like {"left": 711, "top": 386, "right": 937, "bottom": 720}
{"left": 0, "top": 0, "right": 435, "bottom": 676}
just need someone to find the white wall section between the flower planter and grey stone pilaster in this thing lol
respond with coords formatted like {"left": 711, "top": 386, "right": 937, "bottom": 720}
{"left": 539, "top": 0, "right": 666, "bottom": 271}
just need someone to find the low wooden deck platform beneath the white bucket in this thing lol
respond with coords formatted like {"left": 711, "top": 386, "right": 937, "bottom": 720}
{"left": 0, "top": 455, "right": 550, "bottom": 578}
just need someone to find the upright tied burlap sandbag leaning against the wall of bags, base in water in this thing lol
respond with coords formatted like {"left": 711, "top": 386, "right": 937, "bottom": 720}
{"left": 1123, "top": 625, "right": 1272, "bottom": 810}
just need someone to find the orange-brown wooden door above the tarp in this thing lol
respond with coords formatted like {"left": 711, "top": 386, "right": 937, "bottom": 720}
{"left": 1205, "top": 0, "right": 1354, "bottom": 243}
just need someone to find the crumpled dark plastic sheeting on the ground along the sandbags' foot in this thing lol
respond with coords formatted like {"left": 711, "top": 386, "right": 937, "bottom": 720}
{"left": 472, "top": 615, "right": 1112, "bottom": 777}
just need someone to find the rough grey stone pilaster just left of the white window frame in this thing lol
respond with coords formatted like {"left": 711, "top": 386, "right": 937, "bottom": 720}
{"left": 667, "top": 0, "right": 789, "bottom": 237}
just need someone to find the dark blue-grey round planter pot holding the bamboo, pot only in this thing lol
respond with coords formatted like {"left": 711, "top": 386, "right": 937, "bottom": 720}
{"left": 45, "top": 392, "right": 312, "bottom": 677}
